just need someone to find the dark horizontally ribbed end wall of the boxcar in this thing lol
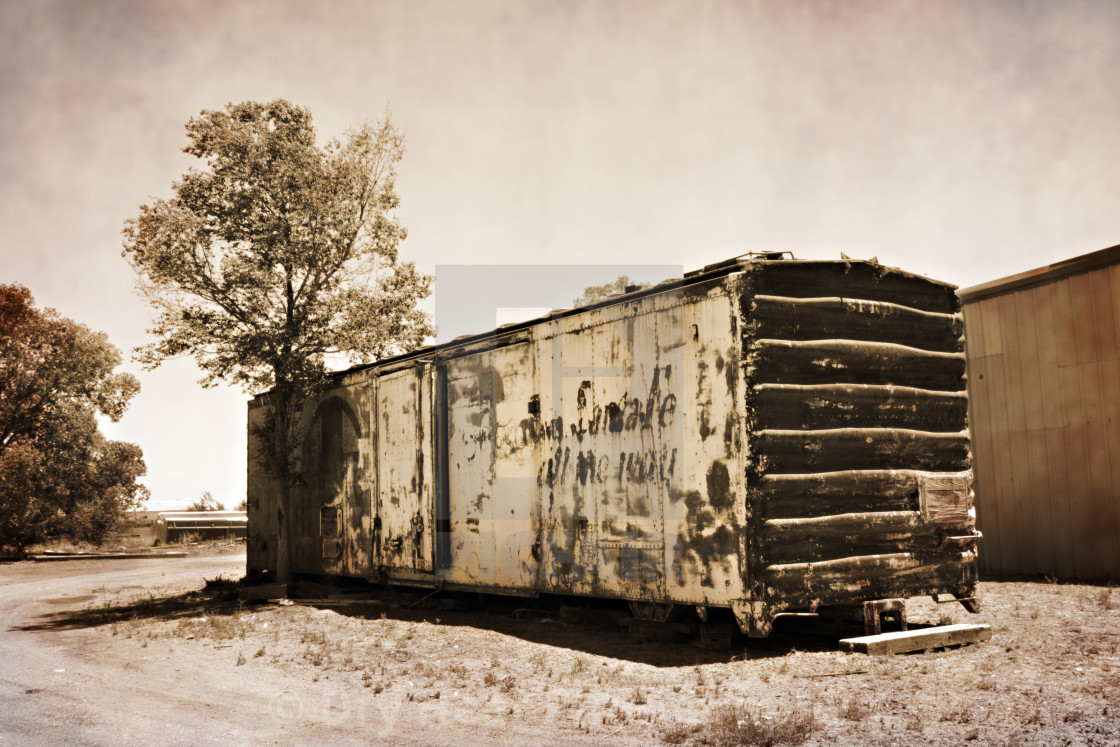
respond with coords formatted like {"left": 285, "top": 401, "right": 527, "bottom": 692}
{"left": 739, "top": 261, "right": 977, "bottom": 635}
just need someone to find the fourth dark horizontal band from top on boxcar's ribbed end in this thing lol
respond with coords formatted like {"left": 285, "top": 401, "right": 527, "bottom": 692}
{"left": 754, "top": 384, "right": 968, "bottom": 432}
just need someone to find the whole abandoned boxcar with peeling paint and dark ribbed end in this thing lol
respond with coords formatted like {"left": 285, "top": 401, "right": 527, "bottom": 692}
{"left": 248, "top": 255, "right": 979, "bottom": 636}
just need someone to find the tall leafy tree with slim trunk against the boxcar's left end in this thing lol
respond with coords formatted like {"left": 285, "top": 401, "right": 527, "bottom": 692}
{"left": 123, "top": 100, "right": 433, "bottom": 581}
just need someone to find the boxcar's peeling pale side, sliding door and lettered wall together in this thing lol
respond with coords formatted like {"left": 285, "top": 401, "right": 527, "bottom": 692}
{"left": 438, "top": 281, "right": 745, "bottom": 605}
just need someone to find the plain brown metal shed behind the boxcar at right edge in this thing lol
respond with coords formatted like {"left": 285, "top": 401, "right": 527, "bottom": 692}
{"left": 959, "top": 246, "right": 1120, "bottom": 579}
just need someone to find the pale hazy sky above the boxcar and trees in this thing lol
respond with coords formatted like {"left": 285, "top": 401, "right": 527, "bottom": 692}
{"left": 0, "top": 0, "right": 1120, "bottom": 508}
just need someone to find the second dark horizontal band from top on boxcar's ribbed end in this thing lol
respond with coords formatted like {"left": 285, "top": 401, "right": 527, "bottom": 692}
{"left": 750, "top": 296, "right": 964, "bottom": 353}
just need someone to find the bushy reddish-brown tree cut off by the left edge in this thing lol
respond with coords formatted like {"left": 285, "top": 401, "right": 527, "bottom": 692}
{"left": 0, "top": 286, "right": 148, "bottom": 553}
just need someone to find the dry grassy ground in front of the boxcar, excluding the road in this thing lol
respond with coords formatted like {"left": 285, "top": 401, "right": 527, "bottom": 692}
{"left": 65, "top": 578, "right": 1120, "bottom": 745}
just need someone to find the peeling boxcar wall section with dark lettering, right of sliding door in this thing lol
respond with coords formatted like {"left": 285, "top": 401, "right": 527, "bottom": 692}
{"left": 504, "top": 284, "right": 741, "bottom": 604}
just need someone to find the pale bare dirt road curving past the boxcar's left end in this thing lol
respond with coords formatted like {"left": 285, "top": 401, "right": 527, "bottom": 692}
{"left": 0, "top": 554, "right": 277, "bottom": 745}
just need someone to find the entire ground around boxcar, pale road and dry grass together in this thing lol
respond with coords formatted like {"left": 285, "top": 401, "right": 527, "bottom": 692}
{"left": 0, "top": 554, "right": 1120, "bottom": 745}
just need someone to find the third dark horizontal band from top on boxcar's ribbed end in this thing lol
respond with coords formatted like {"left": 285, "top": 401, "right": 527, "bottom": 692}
{"left": 747, "top": 339, "right": 964, "bottom": 392}
